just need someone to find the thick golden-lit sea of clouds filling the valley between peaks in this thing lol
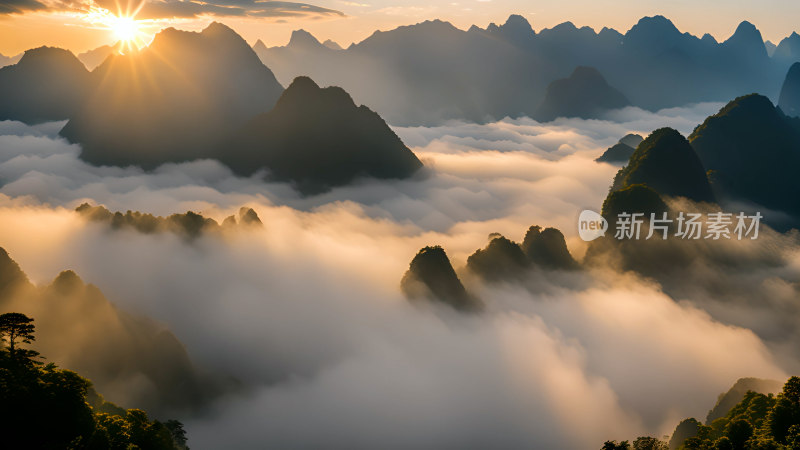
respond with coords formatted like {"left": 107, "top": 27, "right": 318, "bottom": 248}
{"left": 0, "top": 104, "right": 800, "bottom": 449}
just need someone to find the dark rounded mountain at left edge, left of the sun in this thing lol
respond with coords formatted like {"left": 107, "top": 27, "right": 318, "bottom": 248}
{"left": 0, "top": 47, "right": 90, "bottom": 123}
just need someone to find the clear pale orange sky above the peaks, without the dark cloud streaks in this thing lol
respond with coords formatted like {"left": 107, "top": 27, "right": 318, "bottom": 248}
{"left": 0, "top": 0, "right": 800, "bottom": 55}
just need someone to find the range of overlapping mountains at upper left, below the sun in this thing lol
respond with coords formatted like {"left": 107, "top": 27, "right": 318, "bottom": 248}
{"left": 0, "top": 23, "right": 422, "bottom": 193}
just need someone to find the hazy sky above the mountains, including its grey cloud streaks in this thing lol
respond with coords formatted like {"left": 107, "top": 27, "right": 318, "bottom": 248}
{"left": 0, "top": 0, "right": 800, "bottom": 55}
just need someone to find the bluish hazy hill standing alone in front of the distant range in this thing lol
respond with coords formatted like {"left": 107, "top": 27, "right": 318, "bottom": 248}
{"left": 533, "top": 67, "right": 630, "bottom": 122}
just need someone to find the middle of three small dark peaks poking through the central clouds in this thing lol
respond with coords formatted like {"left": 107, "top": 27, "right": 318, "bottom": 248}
{"left": 467, "top": 235, "right": 529, "bottom": 281}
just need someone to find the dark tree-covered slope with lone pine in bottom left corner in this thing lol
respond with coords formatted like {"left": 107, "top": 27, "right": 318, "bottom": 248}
{"left": 0, "top": 313, "right": 188, "bottom": 450}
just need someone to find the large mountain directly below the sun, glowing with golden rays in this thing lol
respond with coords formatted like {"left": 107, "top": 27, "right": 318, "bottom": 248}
{"left": 61, "top": 22, "right": 283, "bottom": 169}
